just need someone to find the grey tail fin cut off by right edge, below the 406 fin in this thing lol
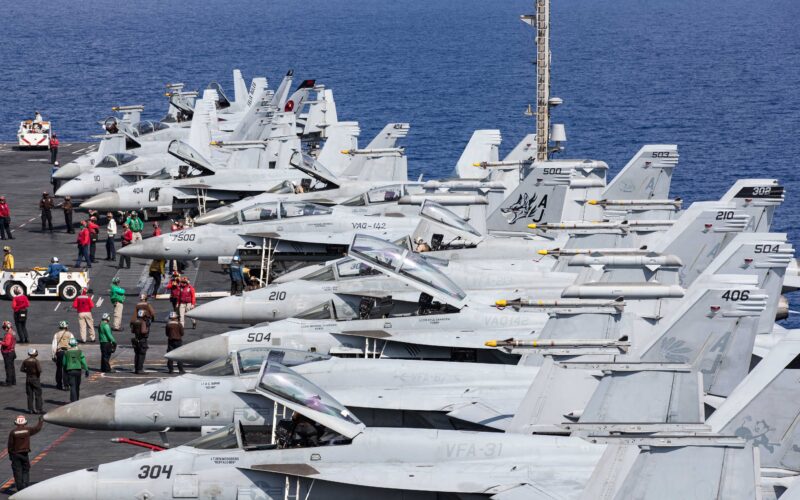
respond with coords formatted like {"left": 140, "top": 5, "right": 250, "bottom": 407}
{"left": 707, "top": 330, "right": 800, "bottom": 472}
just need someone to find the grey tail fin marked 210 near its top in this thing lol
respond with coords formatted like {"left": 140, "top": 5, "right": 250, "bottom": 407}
{"left": 647, "top": 202, "right": 750, "bottom": 287}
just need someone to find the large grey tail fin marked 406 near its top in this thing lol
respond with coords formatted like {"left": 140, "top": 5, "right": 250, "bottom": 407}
{"left": 631, "top": 286, "right": 770, "bottom": 396}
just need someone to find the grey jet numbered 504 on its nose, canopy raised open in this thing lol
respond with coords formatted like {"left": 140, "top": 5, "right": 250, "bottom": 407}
{"left": 167, "top": 225, "right": 793, "bottom": 364}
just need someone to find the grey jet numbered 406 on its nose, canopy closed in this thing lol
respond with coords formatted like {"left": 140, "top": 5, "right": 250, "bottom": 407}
{"left": 40, "top": 248, "right": 785, "bottom": 431}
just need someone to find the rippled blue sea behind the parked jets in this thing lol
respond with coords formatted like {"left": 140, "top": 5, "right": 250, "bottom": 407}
{"left": 0, "top": 0, "right": 800, "bottom": 320}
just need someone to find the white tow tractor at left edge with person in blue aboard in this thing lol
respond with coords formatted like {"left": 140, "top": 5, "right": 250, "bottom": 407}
{"left": 0, "top": 267, "right": 89, "bottom": 300}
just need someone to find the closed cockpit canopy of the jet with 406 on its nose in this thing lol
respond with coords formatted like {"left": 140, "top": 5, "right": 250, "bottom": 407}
{"left": 192, "top": 347, "right": 328, "bottom": 377}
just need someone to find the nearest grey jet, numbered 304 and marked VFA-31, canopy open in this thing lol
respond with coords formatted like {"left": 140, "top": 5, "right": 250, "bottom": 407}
{"left": 17, "top": 297, "right": 758, "bottom": 500}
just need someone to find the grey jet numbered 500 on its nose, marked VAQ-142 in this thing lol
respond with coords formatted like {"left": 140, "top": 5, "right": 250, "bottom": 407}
{"left": 112, "top": 143, "right": 674, "bottom": 272}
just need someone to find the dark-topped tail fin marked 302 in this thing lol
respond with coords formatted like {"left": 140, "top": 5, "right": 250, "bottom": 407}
{"left": 720, "top": 179, "right": 784, "bottom": 233}
